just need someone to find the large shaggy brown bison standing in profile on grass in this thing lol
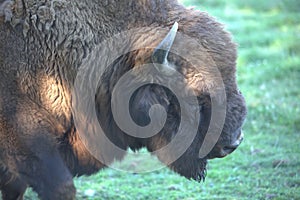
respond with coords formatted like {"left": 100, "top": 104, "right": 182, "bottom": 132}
{"left": 0, "top": 0, "right": 246, "bottom": 199}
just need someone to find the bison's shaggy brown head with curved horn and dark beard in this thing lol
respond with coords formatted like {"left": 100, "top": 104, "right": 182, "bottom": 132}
{"left": 77, "top": 23, "right": 246, "bottom": 180}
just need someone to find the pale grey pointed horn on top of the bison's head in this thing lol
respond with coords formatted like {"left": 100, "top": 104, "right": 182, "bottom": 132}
{"left": 151, "top": 22, "right": 178, "bottom": 74}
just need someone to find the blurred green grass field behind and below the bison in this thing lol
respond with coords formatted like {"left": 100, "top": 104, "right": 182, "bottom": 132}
{"left": 26, "top": 0, "right": 300, "bottom": 200}
